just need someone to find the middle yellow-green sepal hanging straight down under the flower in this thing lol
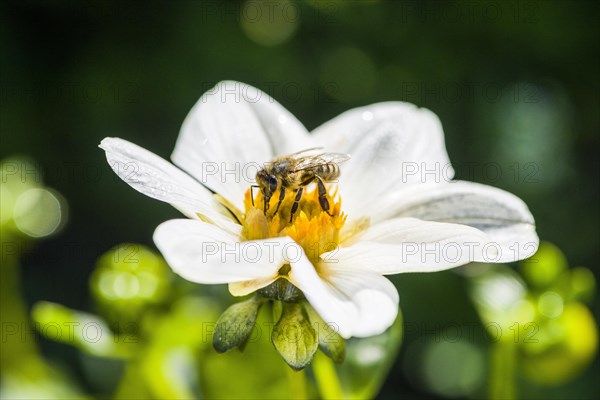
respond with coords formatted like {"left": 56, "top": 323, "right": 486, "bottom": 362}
{"left": 271, "top": 303, "right": 318, "bottom": 371}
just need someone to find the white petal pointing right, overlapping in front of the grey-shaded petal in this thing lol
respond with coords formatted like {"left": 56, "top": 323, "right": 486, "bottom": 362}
{"left": 332, "top": 218, "right": 500, "bottom": 274}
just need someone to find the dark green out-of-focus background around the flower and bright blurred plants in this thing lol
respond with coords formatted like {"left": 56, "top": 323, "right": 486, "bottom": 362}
{"left": 0, "top": 0, "right": 600, "bottom": 398}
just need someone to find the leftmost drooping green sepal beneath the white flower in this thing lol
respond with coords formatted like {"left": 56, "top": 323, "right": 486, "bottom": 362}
{"left": 213, "top": 296, "right": 263, "bottom": 353}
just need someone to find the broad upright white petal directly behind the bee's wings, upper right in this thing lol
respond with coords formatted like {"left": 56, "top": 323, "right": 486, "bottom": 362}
{"left": 314, "top": 102, "right": 454, "bottom": 215}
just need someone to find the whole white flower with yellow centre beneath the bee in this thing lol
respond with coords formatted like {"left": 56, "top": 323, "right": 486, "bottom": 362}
{"left": 100, "top": 82, "right": 538, "bottom": 338}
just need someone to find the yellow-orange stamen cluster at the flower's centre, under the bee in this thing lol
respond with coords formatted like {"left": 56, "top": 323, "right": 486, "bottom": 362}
{"left": 242, "top": 186, "right": 346, "bottom": 264}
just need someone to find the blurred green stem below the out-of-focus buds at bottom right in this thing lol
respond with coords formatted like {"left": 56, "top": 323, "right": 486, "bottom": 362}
{"left": 489, "top": 340, "right": 517, "bottom": 400}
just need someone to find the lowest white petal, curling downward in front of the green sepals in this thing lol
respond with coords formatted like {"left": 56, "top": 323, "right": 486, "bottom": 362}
{"left": 289, "top": 257, "right": 398, "bottom": 338}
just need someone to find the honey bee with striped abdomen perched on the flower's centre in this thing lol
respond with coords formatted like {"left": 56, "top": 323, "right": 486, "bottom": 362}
{"left": 250, "top": 147, "right": 350, "bottom": 222}
